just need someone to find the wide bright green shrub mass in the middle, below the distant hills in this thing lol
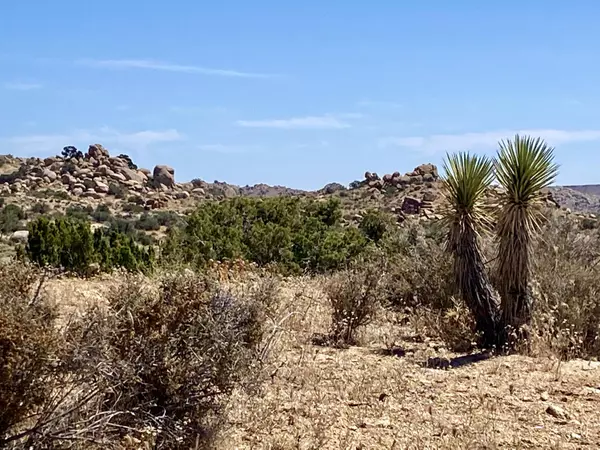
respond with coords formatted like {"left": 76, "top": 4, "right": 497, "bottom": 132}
{"left": 162, "top": 197, "right": 367, "bottom": 272}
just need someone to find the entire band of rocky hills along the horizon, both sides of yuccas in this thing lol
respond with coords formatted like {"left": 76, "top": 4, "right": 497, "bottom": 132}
{"left": 0, "top": 144, "right": 600, "bottom": 239}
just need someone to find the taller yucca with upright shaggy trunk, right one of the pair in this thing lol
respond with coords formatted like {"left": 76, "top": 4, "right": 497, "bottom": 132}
{"left": 496, "top": 135, "right": 558, "bottom": 344}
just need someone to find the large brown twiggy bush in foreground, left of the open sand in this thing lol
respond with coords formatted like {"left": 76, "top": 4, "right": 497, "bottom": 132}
{"left": 61, "top": 274, "right": 262, "bottom": 448}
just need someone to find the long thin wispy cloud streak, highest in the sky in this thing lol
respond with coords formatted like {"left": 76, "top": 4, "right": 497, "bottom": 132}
{"left": 77, "top": 59, "right": 278, "bottom": 78}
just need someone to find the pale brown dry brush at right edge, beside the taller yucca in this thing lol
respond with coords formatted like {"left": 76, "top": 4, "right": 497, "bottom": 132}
{"left": 533, "top": 216, "right": 600, "bottom": 357}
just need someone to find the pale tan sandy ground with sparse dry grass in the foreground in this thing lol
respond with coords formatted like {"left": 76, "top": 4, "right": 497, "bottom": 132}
{"left": 47, "top": 279, "right": 600, "bottom": 449}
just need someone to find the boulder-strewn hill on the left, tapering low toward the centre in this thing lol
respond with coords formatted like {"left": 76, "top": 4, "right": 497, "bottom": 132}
{"left": 0, "top": 144, "right": 318, "bottom": 213}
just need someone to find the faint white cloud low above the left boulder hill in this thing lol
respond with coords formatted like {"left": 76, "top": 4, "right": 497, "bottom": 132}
{"left": 0, "top": 127, "right": 184, "bottom": 156}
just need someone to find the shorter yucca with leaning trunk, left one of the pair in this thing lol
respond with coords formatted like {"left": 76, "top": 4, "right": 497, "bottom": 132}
{"left": 443, "top": 153, "right": 499, "bottom": 347}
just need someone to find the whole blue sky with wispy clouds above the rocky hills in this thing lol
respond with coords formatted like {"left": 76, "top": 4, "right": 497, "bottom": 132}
{"left": 0, "top": 0, "right": 600, "bottom": 189}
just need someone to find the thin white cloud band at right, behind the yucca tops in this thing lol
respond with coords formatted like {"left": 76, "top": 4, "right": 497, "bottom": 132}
{"left": 379, "top": 129, "right": 600, "bottom": 153}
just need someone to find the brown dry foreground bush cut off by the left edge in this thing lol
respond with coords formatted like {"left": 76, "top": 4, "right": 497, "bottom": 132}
{"left": 0, "top": 264, "right": 62, "bottom": 448}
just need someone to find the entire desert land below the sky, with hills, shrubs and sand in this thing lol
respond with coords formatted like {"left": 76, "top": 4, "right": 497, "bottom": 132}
{"left": 0, "top": 137, "right": 600, "bottom": 449}
